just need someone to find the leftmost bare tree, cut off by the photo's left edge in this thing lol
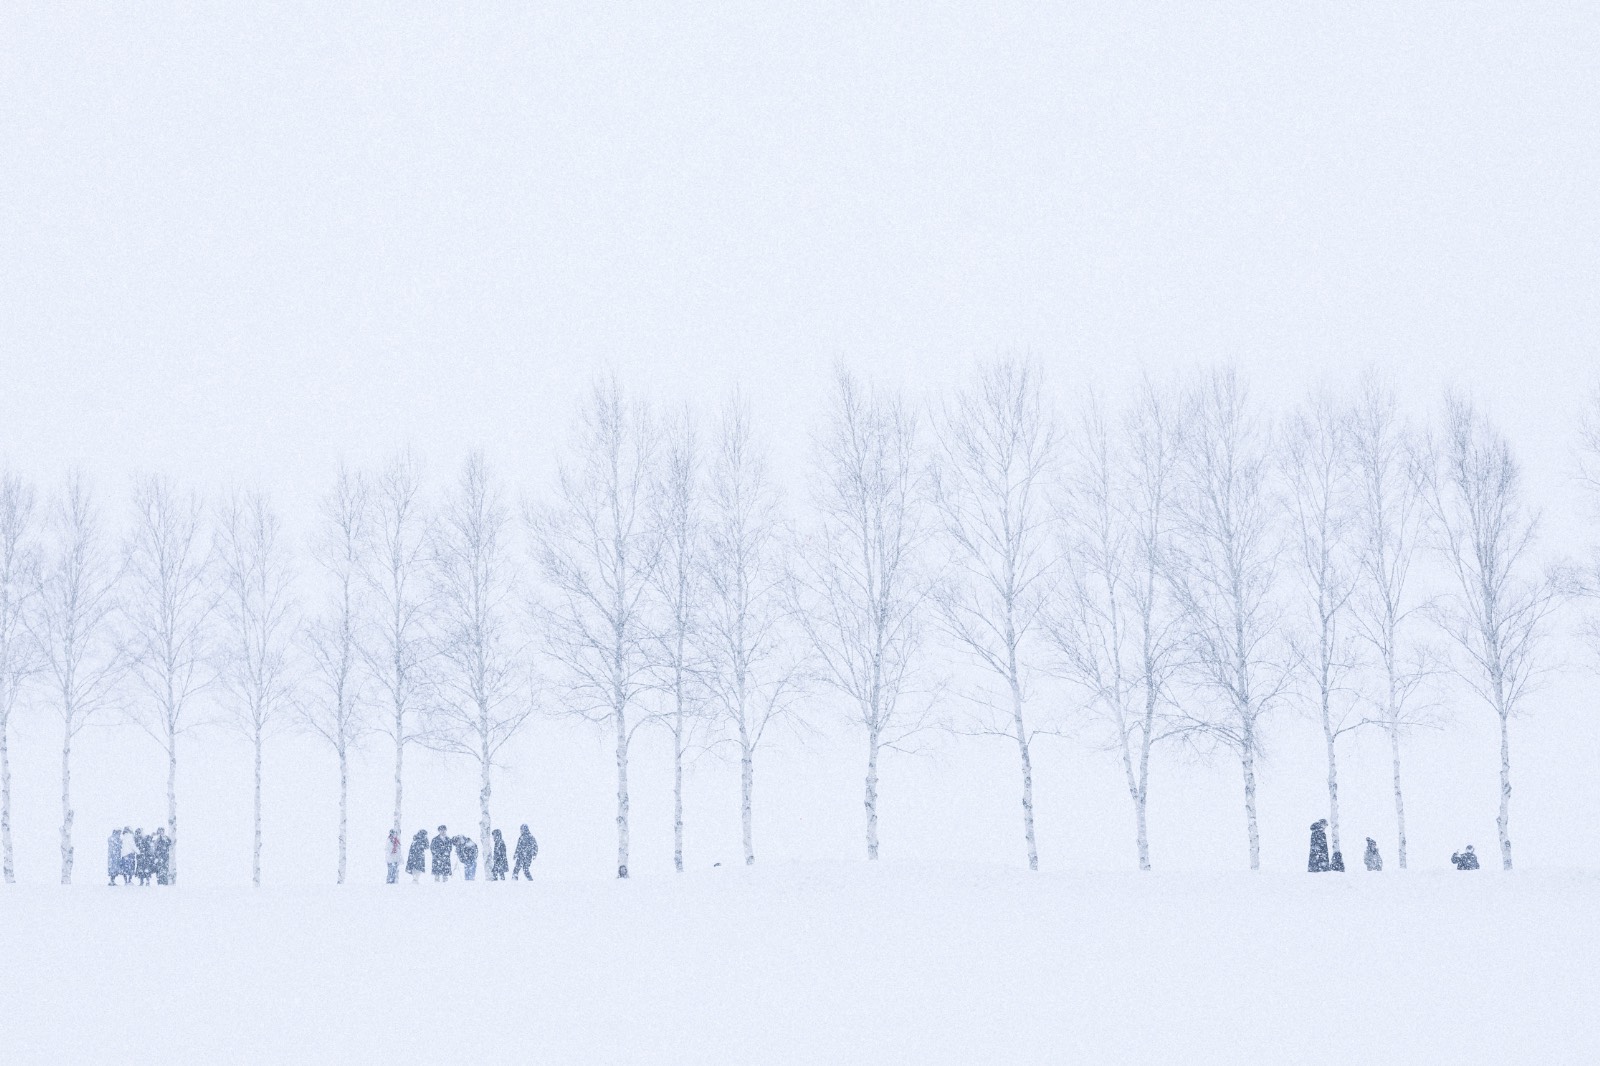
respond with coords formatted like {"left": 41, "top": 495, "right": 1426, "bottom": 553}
{"left": 0, "top": 472, "right": 40, "bottom": 885}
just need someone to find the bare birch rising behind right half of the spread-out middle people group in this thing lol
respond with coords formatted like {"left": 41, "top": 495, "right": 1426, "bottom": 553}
{"left": 419, "top": 453, "right": 533, "bottom": 861}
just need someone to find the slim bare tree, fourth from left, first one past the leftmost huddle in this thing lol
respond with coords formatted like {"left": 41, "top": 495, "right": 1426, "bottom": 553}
{"left": 218, "top": 491, "right": 298, "bottom": 888}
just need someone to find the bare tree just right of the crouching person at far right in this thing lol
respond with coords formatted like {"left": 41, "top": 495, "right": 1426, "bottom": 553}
{"left": 1427, "top": 395, "right": 1555, "bottom": 869}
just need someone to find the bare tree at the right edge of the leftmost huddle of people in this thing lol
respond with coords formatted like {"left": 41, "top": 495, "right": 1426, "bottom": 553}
{"left": 125, "top": 477, "right": 216, "bottom": 884}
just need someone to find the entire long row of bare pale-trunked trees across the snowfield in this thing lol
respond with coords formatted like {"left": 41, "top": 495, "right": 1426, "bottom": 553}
{"left": 0, "top": 360, "right": 1580, "bottom": 884}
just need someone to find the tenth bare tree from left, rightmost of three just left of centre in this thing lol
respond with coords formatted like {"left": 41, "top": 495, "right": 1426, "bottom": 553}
{"left": 706, "top": 395, "right": 802, "bottom": 866}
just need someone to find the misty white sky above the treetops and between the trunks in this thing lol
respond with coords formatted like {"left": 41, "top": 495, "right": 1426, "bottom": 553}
{"left": 0, "top": 2, "right": 1600, "bottom": 884}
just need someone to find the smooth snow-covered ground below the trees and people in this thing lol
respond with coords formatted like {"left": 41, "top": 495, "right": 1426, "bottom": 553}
{"left": 0, "top": 863, "right": 1600, "bottom": 1063}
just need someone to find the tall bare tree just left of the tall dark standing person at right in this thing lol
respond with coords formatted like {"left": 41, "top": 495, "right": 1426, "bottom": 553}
{"left": 1171, "top": 370, "right": 1294, "bottom": 869}
